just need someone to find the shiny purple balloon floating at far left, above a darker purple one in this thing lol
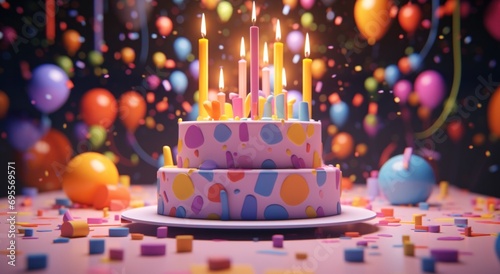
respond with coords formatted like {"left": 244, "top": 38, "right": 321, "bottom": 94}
{"left": 28, "top": 64, "right": 69, "bottom": 113}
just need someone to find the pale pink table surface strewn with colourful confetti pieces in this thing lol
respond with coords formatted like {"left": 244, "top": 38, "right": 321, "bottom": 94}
{"left": 0, "top": 185, "right": 500, "bottom": 274}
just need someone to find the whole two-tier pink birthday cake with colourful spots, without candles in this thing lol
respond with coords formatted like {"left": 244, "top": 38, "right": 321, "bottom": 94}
{"left": 157, "top": 120, "right": 341, "bottom": 220}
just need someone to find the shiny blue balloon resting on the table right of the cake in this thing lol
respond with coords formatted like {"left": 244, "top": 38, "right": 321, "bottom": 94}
{"left": 378, "top": 154, "right": 436, "bottom": 205}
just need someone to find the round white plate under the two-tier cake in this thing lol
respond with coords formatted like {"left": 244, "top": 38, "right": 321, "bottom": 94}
{"left": 122, "top": 205, "right": 377, "bottom": 229}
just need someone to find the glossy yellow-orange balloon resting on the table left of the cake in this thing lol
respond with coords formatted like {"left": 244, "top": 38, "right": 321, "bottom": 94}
{"left": 63, "top": 152, "right": 118, "bottom": 205}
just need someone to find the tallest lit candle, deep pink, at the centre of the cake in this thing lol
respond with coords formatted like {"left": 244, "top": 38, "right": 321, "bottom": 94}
{"left": 250, "top": 2, "right": 259, "bottom": 119}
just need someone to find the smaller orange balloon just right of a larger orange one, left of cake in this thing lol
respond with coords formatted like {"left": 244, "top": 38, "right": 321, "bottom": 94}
{"left": 118, "top": 91, "right": 146, "bottom": 132}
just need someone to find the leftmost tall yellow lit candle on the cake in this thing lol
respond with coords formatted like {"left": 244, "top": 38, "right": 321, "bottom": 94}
{"left": 198, "top": 14, "right": 208, "bottom": 120}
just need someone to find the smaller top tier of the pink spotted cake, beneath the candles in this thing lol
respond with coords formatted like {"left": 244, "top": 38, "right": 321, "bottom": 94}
{"left": 177, "top": 120, "right": 323, "bottom": 169}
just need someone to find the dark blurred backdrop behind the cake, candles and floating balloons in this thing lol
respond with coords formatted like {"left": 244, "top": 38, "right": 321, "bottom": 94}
{"left": 0, "top": 0, "right": 500, "bottom": 197}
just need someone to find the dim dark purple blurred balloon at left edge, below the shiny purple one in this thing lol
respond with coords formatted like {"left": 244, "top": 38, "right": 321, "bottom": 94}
{"left": 6, "top": 118, "right": 44, "bottom": 151}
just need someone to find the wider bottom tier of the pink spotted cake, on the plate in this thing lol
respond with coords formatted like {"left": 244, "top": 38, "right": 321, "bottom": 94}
{"left": 157, "top": 166, "right": 341, "bottom": 220}
